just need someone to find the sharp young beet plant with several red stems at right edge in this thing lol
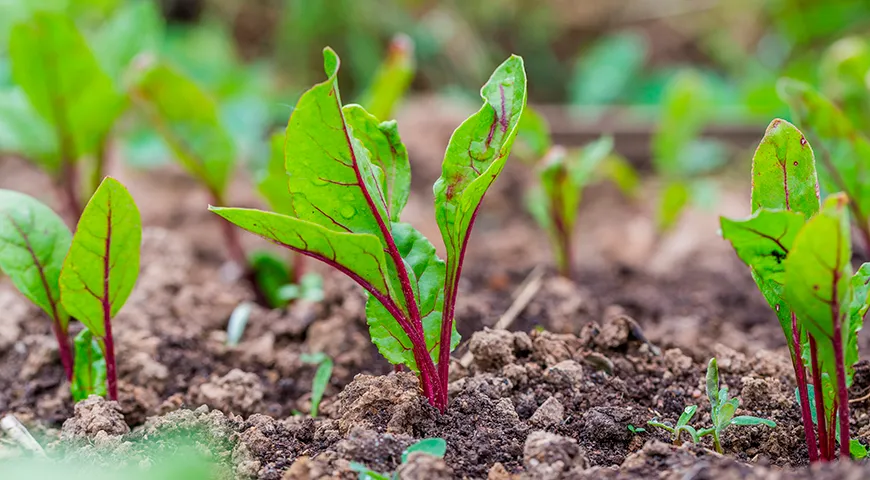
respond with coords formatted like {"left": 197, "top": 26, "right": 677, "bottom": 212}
{"left": 722, "top": 119, "right": 870, "bottom": 461}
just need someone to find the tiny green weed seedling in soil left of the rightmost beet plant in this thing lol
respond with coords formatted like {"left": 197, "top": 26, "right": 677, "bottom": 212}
{"left": 647, "top": 358, "right": 776, "bottom": 453}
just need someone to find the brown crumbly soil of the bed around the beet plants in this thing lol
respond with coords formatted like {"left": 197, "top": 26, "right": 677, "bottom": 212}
{"left": 0, "top": 99, "right": 870, "bottom": 479}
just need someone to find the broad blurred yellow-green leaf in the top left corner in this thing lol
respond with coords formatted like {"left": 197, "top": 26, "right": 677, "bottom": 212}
{"left": 9, "top": 12, "right": 125, "bottom": 161}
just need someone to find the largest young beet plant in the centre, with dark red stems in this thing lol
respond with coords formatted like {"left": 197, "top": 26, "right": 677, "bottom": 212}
{"left": 210, "top": 48, "right": 526, "bottom": 412}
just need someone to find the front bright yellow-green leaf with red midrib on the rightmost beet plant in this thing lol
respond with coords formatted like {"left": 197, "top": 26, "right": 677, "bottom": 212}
{"left": 785, "top": 194, "right": 852, "bottom": 406}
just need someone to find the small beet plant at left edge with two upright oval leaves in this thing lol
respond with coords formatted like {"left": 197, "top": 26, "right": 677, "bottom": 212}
{"left": 0, "top": 177, "right": 142, "bottom": 400}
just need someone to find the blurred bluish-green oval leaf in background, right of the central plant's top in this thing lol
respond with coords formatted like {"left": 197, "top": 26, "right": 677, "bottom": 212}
{"left": 569, "top": 32, "right": 647, "bottom": 105}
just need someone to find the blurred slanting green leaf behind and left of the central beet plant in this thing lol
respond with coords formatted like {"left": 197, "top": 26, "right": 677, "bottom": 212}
{"left": 129, "top": 61, "right": 236, "bottom": 199}
